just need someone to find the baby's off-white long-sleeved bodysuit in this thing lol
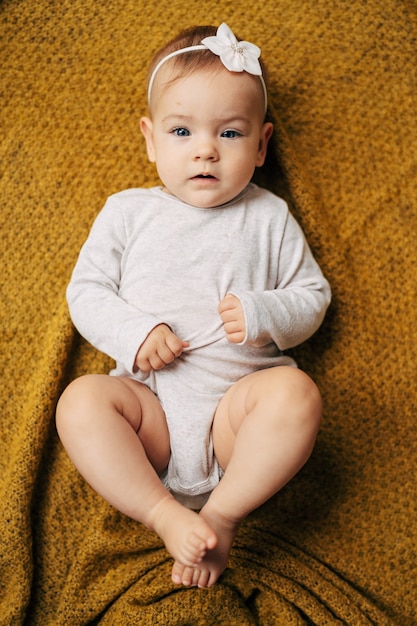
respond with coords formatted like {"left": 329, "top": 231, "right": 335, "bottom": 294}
{"left": 67, "top": 184, "right": 330, "bottom": 508}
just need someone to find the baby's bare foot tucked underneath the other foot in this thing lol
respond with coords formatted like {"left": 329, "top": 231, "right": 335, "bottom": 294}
{"left": 172, "top": 503, "right": 238, "bottom": 587}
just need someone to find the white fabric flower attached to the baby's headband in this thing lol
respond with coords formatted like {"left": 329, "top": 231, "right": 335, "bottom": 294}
{"left": 201, "top": 23, "right": 262, "bottom": 76}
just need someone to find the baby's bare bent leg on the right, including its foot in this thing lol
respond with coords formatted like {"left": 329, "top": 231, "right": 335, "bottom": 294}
{"left": 173, "top": 366, "right": 321, "bottom": 587}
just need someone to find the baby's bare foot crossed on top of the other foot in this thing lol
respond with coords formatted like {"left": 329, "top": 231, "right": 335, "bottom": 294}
{"left": 150, "top": 496, "right": 217, "bottom": 567}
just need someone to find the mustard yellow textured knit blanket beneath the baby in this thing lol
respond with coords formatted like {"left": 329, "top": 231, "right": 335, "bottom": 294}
{"left": 0, "top": 0, "right": 417, "bottom": 626}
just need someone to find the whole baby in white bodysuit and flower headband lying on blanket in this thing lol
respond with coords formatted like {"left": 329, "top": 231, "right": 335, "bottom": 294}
{"left": 57, "top": 24, "right": 330, "bottom": 587}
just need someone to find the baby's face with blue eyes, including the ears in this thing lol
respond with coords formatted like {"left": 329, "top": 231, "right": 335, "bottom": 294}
{"left": 141, "top": 67, "right": 272, "bottom": 208}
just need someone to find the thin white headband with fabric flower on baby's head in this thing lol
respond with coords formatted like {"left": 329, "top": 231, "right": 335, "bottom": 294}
{"left": 148, "top": 24, "right": 268, "bottom": 113}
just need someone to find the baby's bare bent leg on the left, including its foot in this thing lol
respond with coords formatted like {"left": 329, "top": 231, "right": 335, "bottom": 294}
{"left": 56, "top": 375, "right": 217, "bottom": 566}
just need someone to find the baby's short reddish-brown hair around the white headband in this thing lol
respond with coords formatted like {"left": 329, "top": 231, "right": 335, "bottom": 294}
{"left": 147, "top": 25, "right": 268, "bottom": 113}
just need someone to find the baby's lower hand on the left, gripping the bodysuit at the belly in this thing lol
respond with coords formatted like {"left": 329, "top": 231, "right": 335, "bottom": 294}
{"left": 135, "top": 324, "right": 190, "bottom": 372}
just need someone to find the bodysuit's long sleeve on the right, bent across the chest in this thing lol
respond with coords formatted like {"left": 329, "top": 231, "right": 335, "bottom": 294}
{"left": 233, "top": 208, "right": 331, "bottom": 350}
